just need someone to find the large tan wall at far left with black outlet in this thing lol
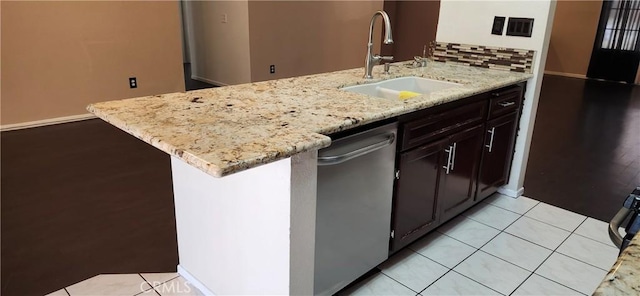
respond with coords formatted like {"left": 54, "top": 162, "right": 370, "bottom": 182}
{"left": 1, "top": 1, "right": 184, "bottom": 125}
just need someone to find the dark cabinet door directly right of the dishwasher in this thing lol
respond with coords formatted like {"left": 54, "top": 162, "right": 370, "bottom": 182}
{"left": 391, "top": 140, "right": 447, "bottom": 251}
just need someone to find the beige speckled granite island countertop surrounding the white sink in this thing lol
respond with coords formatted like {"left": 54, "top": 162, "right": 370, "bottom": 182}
{"left": 87, "top": 62, "right": 533, "bottom": 177}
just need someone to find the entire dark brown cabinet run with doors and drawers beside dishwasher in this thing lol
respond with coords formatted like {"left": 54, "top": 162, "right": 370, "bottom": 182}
{"left": 390, "top": 85, "right": 523, "bottom": 253}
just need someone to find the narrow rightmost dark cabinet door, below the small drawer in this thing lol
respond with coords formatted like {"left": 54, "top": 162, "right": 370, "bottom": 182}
{"left": 476, "top": 112, "right": 518, "bottom": 201}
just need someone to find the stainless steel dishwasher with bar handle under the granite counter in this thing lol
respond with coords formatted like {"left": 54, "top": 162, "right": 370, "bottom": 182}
{"left": 314, "top": 123, "right": 397, "bottom": 295}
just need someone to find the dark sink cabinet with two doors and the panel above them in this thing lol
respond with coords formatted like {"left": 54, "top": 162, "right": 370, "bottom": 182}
{"left": 391, "top": 98, "right": 487, "bottom": 251}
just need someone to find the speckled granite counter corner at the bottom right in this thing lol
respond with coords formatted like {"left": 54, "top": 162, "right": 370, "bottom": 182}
{"left": 594, "top": 235, "right": 640, "bottom": 295}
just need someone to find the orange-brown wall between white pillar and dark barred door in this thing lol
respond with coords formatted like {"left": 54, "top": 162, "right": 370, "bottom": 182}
{"left": 545, "top": 1, "right": 602, "bottom": 75}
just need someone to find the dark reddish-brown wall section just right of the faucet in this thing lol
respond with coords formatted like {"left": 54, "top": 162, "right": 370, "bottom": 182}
{"left": 382, "top": 1, "right": 440, "bottom": 61}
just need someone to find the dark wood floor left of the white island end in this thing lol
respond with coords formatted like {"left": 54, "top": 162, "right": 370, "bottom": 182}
{"left": 1, "top": 119, "right": 178, "bottom": 296}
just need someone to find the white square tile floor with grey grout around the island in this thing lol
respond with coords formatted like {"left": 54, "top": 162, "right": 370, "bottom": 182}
{"left": 49, "top": 195, "right": 618, "bottom": 296}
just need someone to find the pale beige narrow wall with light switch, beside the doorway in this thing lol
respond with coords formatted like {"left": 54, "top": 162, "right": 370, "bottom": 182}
{"left": 185, "top": 0, "right": 251, "bottom": 85}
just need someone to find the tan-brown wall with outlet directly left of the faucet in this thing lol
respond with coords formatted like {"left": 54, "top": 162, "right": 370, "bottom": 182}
{"left": 249, "top": 1, "right": 383, "bottom": 81}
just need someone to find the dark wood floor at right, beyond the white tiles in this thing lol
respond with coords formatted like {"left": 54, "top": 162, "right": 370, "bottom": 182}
{"left": 524, "top": 75, "right": 640, "bottom": 222}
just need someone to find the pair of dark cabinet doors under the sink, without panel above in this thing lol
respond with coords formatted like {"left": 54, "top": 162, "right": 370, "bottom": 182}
{"left": 391, "top": 125, "right": 484, "bottom": 251}
